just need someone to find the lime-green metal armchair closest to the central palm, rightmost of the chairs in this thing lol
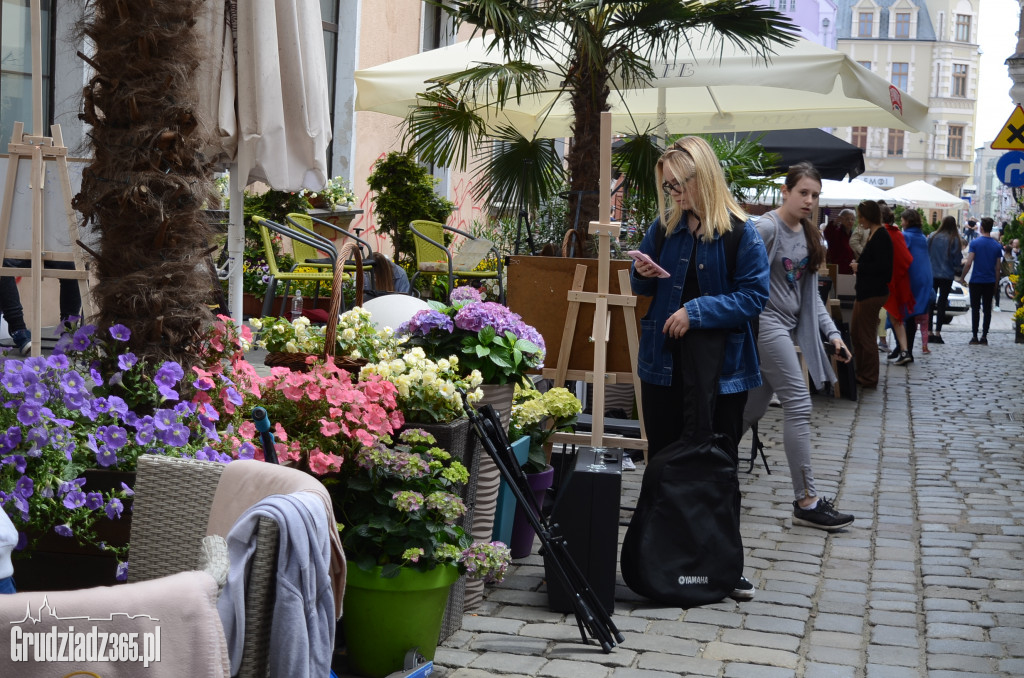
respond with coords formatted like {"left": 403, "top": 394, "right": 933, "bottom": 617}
{"left": 409, "top": 219, "right": 505, "bottom": 303}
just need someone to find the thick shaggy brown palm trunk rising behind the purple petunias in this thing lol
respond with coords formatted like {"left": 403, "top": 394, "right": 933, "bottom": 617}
{"left": 75, "top": 0, "right": 214, "bottom": 366}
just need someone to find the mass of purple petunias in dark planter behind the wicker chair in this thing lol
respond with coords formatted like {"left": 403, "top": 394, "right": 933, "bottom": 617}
{"left": 0, "top": 321, "right": 256, "bottom": 589}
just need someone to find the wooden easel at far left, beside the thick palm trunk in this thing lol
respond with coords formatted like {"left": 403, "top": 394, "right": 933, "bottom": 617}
{"left": 0, "top": 0, "right": 92, "bottom": 355}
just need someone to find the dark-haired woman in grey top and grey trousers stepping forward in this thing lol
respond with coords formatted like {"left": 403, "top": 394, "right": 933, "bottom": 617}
{"left": 743, "top": 163, "right": 853, "bottom": 532}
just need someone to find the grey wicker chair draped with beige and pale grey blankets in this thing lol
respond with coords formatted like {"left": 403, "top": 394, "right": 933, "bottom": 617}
{"left": 129, "top": 455, "right": 279, "bottom": 678}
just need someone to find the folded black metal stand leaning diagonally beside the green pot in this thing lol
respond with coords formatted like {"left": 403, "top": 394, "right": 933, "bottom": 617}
{"left": 462, "top": 391, "right": 626, "bottom": 653}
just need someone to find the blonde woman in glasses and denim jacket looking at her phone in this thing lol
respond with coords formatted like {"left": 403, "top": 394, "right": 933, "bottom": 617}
{"left": 631, "top": 136, "right": 768, "bottom": 600}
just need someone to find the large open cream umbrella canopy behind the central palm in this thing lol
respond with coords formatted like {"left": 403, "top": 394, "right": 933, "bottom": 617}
{"left": 355, "top": 32, "right": 928, "bottom": 137}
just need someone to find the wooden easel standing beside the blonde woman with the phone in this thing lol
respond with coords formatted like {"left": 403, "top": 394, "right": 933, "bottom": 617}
{"left": 543, "top": 113, "right": 647, "bottom": 460}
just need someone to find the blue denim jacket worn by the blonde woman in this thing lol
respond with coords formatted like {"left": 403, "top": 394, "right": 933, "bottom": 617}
{"left": 630, "top": 215, "right": 769, "bottom": 393}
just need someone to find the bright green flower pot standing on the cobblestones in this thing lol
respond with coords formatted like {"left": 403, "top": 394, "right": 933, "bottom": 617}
{"left": 343, "top": 565, "right": 459, "bottom": 678}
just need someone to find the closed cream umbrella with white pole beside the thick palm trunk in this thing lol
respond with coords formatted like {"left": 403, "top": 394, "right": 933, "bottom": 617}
{"left": 200, "top": 0, "right": 331, "bottom": 321}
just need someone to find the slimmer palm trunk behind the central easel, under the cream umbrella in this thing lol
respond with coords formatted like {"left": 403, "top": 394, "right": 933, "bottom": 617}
{"left": 566, "top": 55, "right": 611, "bottom": 256}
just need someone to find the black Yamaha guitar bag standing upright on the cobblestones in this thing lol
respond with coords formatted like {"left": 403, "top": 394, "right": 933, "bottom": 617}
{"left": 621, "top": 330, "right": 743, "bottom": 607}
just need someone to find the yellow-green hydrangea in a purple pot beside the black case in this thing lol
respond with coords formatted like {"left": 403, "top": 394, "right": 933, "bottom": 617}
{"left": 509, "top": 386, "right": 583, "bottom": 558}
